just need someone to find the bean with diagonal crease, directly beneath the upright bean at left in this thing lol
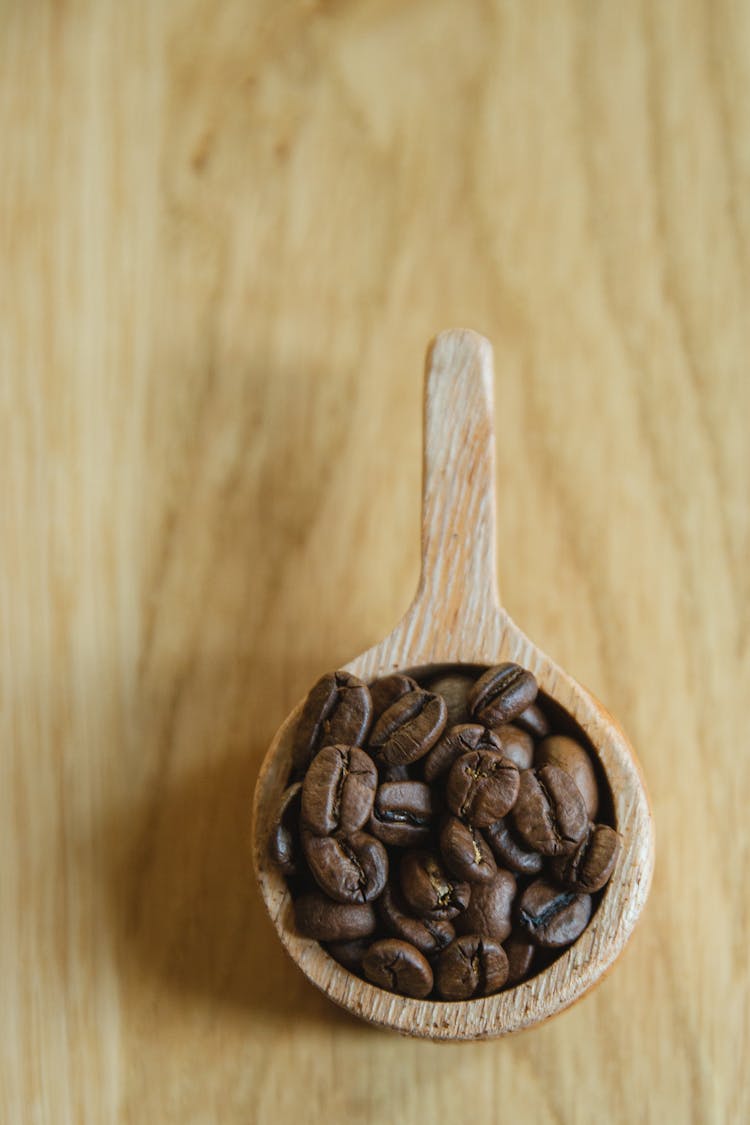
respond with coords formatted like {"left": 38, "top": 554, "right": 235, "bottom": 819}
{"left": 302, "top": 829, "right": 388, "bottom": 902}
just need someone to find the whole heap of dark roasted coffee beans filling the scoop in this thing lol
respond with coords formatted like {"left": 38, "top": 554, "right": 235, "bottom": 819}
{"left": 270, "top": 664, "right": 620, "bottom": 1000}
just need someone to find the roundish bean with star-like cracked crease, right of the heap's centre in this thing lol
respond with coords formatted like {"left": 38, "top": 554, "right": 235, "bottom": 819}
{"left": 445, "top": 750, "right": 518, "bottom": 828}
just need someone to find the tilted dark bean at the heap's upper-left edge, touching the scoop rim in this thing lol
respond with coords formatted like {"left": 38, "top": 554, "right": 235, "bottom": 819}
{"left": 292, "top": 672, "right": 372, "bottom": 771}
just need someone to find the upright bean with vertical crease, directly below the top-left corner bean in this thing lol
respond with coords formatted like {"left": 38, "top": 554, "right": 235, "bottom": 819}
{"left": 302, "top": 746, "right": 378, "bottom": 836}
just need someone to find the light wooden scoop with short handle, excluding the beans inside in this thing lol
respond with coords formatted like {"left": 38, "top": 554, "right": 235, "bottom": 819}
{"left": 253, "top": 331, "right": 653, "bottom": 1040}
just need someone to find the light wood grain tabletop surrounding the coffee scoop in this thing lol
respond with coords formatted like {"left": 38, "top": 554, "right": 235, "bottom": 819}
{"left": 0, "top": 0, "right": 750, "bottom": 1125}
